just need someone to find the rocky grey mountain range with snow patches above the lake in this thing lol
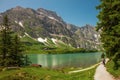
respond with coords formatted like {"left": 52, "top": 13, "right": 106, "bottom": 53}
{"left": 0, "top": 6, "right": 101, "bottom": 50}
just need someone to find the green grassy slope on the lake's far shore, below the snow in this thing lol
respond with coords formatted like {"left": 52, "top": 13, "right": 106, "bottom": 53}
{"left": 21, "top": 36, "right": 95, "bottom": 54}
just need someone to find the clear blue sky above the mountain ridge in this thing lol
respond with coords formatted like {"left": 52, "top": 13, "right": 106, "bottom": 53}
{"left": 0, "top": 0, "right": 100, "bottom": 27}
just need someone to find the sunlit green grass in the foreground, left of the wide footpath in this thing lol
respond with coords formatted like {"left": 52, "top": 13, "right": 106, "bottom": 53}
{"left": 0, "top": 67, "right": 95, "bottom": 80}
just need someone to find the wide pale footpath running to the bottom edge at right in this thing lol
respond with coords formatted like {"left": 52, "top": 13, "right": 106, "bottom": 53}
{"left": 94, "top": 59, "right": 115, "bottom": 80}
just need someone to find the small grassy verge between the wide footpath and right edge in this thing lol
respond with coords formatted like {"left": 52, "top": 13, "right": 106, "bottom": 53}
{"left": 106, "top": 60, "right": 120, "bottom": 78}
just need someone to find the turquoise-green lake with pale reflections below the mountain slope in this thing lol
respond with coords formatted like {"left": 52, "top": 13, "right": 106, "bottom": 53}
{"left": 28, "top": 52, "right": 101, "bottom": 68}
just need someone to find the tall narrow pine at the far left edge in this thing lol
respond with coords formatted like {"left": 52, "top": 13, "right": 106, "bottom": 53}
{"left": 0, "top": 15, "right": 12, "bottom": 66}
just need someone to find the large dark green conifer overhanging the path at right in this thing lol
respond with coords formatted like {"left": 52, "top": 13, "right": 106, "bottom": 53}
{"left": 97, "top": 0, "right": 120, "bottom": 68}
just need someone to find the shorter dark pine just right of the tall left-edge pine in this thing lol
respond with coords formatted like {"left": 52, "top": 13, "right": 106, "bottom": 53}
{"left": 10, "top": 35, "right": 24, "bottom": 66}
